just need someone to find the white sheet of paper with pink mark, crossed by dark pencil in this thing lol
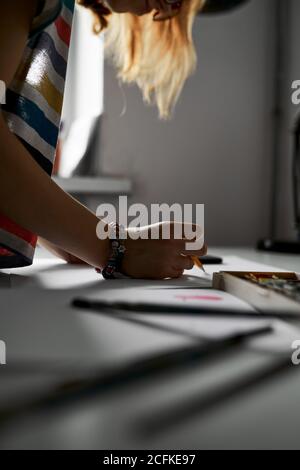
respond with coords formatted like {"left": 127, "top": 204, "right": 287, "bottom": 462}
{"left": 75, "top": 288, "right": 271, "bottom": 340}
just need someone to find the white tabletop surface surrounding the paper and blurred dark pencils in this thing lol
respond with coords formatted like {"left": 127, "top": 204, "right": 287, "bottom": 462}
{"left": 0, "top": 248, "right": 300, "bottom": 449}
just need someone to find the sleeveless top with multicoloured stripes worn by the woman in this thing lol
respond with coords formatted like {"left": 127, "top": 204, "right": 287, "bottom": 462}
{"left": 0, "top": 0, "right": 75, "bottom": 268}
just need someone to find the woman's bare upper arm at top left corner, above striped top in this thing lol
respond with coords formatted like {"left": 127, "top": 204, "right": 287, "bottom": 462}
{"left": 0, "top": 0, "right": 39, "bottom": 83}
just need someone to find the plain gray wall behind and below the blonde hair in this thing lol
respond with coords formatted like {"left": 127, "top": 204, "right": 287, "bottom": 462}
{"left": 101, "top": 0, "right": 276, "bottom": 245}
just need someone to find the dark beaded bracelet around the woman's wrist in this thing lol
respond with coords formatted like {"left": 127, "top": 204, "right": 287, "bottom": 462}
{"left": 96, "top": 222, "right": 126, "bottom": 279}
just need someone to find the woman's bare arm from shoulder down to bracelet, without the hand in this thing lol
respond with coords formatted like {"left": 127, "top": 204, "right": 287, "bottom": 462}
{"left": 0, "top": 0, "right": 109, "bottom": 267}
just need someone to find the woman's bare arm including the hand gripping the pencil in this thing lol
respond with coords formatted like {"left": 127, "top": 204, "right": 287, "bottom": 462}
{"left": 0, "top": 0, "right": 205, "bottom": 279}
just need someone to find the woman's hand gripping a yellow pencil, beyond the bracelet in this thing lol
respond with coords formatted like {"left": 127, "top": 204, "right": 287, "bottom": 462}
{"left": 122, "top": 222, "right": 207, "bottom": 279}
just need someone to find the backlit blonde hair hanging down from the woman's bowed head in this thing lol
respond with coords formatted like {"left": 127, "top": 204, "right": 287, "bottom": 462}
{"left": 79, "top": 0, "right": 205, "bottom": 118}
